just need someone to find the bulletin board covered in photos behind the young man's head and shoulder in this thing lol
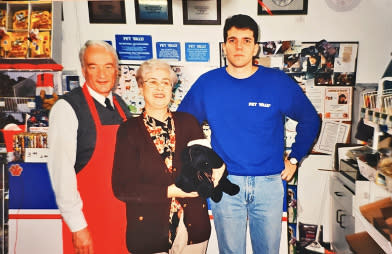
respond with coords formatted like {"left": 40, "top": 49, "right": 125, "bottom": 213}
{"left": 220, "top": 40, "right": 358, "bottom": 86}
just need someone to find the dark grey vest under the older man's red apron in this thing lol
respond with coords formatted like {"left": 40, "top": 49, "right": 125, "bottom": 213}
{"left": 61, "top": 87, "right": 131, "bottom": 173}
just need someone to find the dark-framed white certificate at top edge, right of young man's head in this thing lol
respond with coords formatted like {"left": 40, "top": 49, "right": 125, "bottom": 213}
{"left": 257, "top": 0, "right": 308, "bottom": 15}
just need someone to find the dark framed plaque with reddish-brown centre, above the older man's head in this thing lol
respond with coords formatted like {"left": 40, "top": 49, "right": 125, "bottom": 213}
{"left": 88, "top": 0, "right": 126, "bottom": 24}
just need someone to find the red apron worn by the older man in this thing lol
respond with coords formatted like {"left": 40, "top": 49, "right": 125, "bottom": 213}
{"left": 63, "top": 85, "right": 129, "bottom": 254}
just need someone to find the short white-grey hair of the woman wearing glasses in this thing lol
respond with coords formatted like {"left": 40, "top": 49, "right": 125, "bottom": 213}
{"left": 136, "top": 59, "right": 178, "bottom": 87}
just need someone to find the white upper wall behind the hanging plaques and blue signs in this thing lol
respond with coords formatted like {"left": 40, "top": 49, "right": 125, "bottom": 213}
{"left": 62, "top": 0, "right": 392, "bottom": 83}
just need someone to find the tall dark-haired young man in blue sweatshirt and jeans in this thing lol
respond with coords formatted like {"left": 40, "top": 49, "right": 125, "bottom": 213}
{"left": 178, "top": 15, "right": 320, "bottom": 254}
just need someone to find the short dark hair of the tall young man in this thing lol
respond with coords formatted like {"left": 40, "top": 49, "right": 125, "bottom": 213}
{"left": 223, "top": 14, "right": 259, "bottom": 43}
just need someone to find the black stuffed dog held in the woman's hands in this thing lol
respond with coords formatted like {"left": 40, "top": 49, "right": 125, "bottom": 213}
{"left": 175, "top": 139, "right": 240, "bottom": 202}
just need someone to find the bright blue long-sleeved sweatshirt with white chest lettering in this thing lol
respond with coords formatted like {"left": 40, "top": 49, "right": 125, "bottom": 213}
{"left": 178, "top": 66, "right": 320, "bottom": 176}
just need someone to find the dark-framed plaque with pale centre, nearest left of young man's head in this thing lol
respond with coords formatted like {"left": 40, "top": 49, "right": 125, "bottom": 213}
{"left": 182, "top": 0, "right": 221, "bottom": 25}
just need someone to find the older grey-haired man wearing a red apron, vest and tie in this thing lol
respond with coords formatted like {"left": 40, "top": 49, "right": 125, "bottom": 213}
{"left": 48, "top": 41, "right": 130, "bottom": 254}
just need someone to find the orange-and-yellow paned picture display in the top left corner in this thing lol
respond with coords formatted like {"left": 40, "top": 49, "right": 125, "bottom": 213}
{"left": 0, "top": 1, "right": 61, "bottom": 63}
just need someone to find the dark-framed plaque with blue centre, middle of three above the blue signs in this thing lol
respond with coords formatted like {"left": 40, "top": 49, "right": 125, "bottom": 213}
{"left": 135, "top": 0, "right": 173, "bottom": 24}
